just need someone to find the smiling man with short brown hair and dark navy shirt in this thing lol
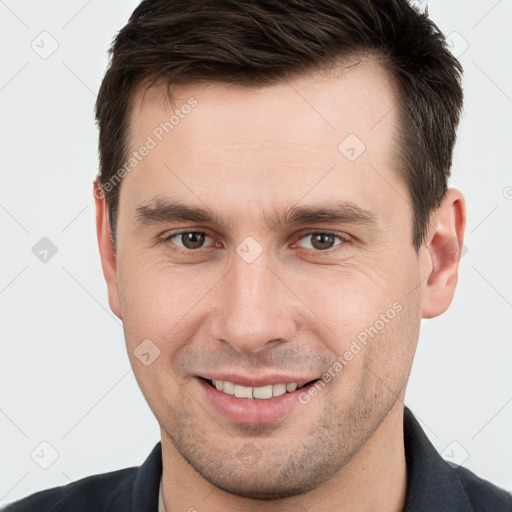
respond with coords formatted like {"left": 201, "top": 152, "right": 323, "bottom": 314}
{"left": 2, "top": 0, "right": 512, "bottom": 512}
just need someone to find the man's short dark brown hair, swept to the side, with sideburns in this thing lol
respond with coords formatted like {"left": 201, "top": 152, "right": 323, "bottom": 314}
{"left": 96, "top": 0, "right": 463, "bottom": 249}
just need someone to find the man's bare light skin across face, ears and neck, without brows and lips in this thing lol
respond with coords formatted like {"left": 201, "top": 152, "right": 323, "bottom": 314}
{"left": 95, "top": 61, "right": 466, "bottom": 512}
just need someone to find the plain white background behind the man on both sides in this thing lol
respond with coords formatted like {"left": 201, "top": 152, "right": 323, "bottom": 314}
{"left": 0, "top": 0, "right": 512, "bottom": 504}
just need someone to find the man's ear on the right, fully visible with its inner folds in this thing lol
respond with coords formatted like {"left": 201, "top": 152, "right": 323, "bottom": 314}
{"left": 422, "top": 188, "right": 466, "bottom": 318}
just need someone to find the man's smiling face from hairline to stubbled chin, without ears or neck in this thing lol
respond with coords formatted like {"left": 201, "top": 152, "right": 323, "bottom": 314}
{"left": 99, "top": 59, "right": 424, "bottom": 498}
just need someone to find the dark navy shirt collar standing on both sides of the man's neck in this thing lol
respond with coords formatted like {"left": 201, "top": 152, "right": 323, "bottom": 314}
{"left": 131, "top": 407, "right": 473, "bottom": 512}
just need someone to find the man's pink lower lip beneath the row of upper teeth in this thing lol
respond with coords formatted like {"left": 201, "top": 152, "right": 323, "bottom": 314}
{"left": 197, "top": 378, "right": 315, "bottom": 425}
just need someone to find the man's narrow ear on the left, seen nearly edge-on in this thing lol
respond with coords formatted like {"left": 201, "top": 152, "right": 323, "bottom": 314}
{"left": 93, "top": 180, "right": 122, "bottom": 320}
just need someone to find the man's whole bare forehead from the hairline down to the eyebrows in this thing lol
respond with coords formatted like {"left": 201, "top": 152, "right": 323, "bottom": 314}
{"left": 121, "top": 57, "right": 403, "bottom": 228}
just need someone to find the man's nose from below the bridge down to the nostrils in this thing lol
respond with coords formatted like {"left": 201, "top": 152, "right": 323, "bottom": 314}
{"left": 210, "top": 254, "right": 297, "bottom": 353}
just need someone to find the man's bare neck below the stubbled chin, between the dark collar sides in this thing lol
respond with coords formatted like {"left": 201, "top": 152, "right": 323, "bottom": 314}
{"left": 161, "top": 401, "right": 407, "bottom": 512}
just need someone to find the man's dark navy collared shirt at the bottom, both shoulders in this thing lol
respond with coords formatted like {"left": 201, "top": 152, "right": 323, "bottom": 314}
{"left": 3, "top": 407, "right": 512, "bottom": 512}
